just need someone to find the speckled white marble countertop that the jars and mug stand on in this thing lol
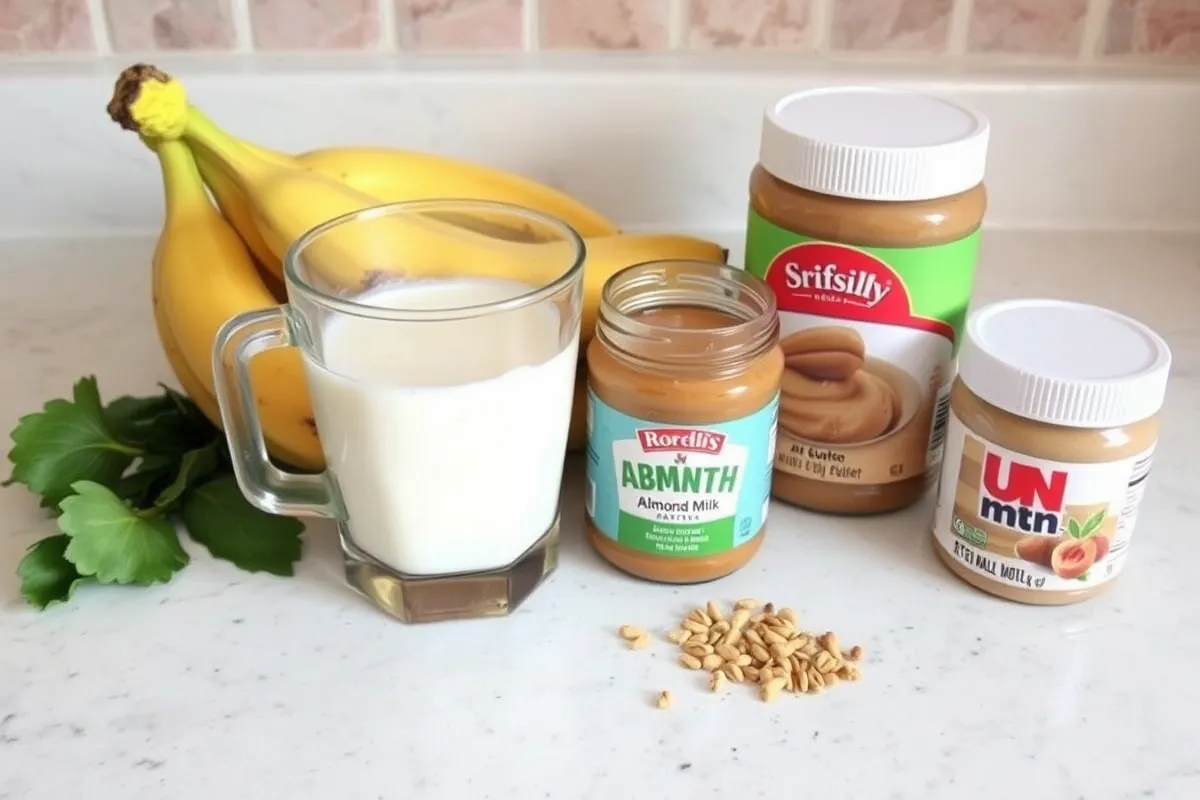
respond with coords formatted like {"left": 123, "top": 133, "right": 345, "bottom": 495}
{"left": 0, "top": 230, "right": 1200, "bottom": 800}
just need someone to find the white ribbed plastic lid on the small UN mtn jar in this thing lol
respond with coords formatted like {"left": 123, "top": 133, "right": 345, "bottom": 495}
{"left": 959, "top": 300, "right": 1171, "bottom": 428}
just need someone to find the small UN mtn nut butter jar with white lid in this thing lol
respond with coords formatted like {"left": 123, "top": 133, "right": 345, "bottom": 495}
{"left": 934, "top": 300, "right": 1171, "bottom": 606}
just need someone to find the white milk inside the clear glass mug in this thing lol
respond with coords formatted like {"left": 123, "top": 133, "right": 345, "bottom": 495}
{"left": 305, "top": 278, "right": 578, "bottom": 575}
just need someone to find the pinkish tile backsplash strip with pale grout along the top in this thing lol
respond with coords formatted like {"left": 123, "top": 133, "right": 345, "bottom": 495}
{"left": 0, "top": 0, "right": 1200, "bottom": 66}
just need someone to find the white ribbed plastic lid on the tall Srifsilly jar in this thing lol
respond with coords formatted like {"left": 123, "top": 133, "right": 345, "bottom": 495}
{"left": 758, "top": 86, "right": 989, "bottom": 201}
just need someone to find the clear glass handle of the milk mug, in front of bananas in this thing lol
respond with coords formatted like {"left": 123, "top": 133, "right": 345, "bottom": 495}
{"left": 212, "top": 306, "right": 343, "bottom": 519}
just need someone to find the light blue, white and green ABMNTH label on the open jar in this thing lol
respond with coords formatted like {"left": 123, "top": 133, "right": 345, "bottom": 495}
{"left": 586, "top": 390, "right": 779, "bottom": 558}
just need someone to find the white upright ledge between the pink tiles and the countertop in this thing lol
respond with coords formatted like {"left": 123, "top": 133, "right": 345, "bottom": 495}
{"left": 0, "top": 58, "right": 1200, "bottom": 239}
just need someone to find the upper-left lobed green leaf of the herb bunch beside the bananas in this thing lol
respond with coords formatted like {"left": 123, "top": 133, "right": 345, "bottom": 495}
{"left": 8, "top": 377, "right": 142, "bottom": 506}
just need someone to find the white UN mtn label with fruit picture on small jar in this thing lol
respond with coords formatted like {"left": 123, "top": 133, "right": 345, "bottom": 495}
{"left": 934, "top": 413, "right": 1153, "bottom": 591}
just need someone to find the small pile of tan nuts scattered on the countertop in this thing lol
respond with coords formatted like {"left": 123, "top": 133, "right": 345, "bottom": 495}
{"left": 618, "top": 597, "right": 863, "bottom": 709}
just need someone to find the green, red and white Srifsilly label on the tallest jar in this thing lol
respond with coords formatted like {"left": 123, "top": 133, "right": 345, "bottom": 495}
{"left": 745, "top": 209, "right": 979, "bottom": 485}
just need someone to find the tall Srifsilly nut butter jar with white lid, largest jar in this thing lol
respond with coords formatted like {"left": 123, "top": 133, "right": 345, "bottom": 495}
{"left": 745, "top": 88, "right": 989, "bottom": 515}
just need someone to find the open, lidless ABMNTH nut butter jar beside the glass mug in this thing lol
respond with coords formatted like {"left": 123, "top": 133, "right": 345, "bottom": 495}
{"left": 586, "top": 260, "right": 784, "bottom": 583}
